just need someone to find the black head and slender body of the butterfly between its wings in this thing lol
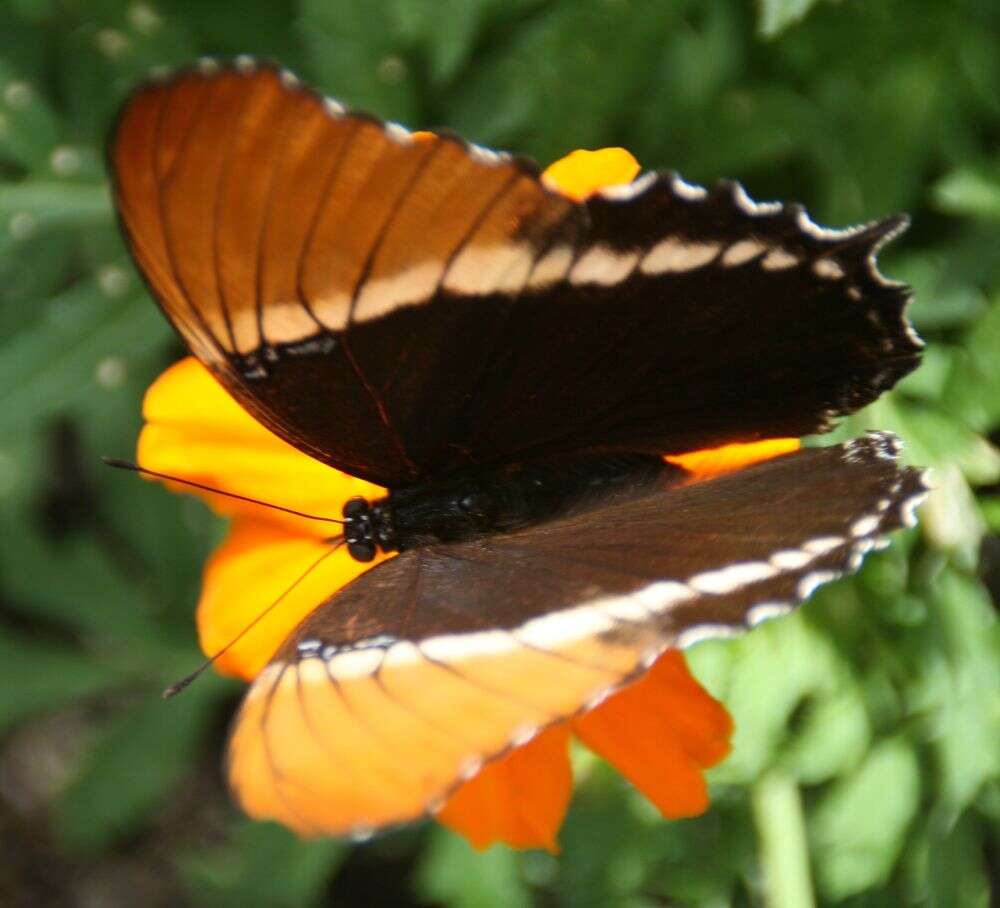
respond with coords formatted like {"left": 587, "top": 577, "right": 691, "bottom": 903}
{"left": 343, "top": 453, "right": 675, "bottom": 561}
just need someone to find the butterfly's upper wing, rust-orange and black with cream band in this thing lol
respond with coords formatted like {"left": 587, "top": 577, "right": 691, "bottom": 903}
{"left": 109, "top": 61, "right": 919, "bottom": 487}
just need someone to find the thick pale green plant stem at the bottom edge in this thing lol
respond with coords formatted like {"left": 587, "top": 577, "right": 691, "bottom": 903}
{"left": 751, "top": 770, "right": 816, "bottom": 908}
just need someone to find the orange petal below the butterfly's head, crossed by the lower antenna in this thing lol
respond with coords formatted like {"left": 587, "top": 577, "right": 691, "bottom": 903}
{"left": 198, "top": 518, "right": 383, "bottom": 680}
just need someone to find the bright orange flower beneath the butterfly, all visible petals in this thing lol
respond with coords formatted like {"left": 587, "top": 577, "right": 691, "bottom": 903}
{"left": 138, "top": 149, "right": 798, "bottom": 851}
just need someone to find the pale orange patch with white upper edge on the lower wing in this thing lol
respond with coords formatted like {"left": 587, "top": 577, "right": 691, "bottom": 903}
{"left": 229, "top": 625, "right": 643, "bottom": 836}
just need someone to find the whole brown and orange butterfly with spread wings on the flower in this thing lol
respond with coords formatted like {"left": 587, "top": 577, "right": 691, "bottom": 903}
{"left": 108, "top": 58, "right": 926, "bottom": 834}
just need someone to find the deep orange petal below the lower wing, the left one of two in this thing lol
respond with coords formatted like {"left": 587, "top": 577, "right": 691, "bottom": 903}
{"left": 437, "top": 719, "right": 573, "bottom": 852}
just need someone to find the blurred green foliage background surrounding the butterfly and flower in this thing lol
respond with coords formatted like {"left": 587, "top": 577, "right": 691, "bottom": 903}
{"left": 0, "top": 0, "right": 1000, "bottom": 908}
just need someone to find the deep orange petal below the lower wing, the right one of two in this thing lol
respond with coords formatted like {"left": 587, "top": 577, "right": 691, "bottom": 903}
{"left": 573, "top": 650, "right": 732, "bottom": 818}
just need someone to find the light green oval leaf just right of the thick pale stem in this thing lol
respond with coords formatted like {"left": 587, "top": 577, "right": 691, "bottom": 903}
{"left": 810, "top": 738, "right": 921, "bottom": 901}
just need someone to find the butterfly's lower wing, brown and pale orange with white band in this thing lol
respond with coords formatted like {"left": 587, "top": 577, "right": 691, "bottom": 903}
{"left": 229, "top": 434, "right": 926, "bottom": 834}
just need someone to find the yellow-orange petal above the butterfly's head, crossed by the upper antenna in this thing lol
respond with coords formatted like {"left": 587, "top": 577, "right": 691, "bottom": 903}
{"left": 137, "top": 357, "right": 384, "bottom": 538}
